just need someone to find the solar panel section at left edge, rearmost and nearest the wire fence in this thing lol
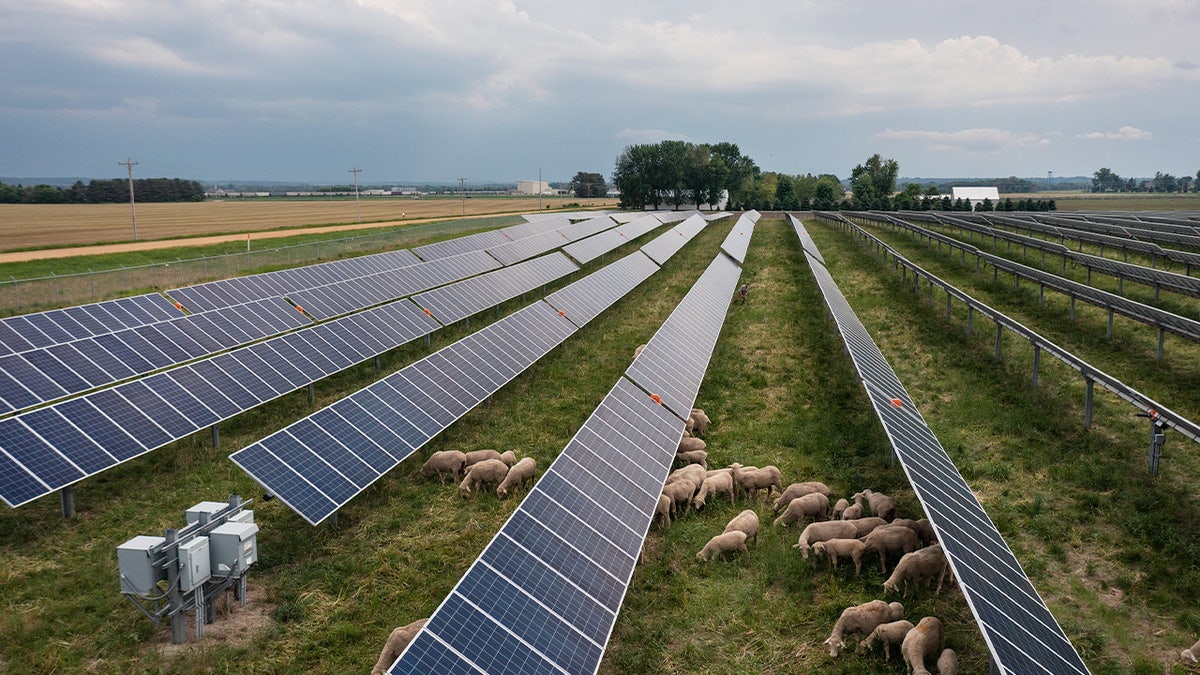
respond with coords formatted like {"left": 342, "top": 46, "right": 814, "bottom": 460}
{"left": 0, "top": 293, "right": 181, "bottom": 357}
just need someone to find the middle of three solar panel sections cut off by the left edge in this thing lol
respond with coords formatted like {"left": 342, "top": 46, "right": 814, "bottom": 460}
{"left": 0, "top": 299, "right": 311, "bottom": 415}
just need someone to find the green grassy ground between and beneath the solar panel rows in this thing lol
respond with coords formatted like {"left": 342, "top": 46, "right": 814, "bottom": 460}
{"left": 0, "top": 211, "right": 1200, "bottom": 674}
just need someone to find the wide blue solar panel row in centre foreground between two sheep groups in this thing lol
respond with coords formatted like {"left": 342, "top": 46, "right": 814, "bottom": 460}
{"left": 389, "top": 248, "right": 740, "bottom": 675}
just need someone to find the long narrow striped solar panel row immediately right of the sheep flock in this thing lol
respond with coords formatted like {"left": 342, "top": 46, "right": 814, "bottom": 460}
{"left": 793, "top": 221, "right": 1087, "bottom": 675}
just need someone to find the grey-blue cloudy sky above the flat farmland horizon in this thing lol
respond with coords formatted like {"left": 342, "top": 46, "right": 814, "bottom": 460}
{"left": 0, "top": 0, "right": 1200, "bottom": 184}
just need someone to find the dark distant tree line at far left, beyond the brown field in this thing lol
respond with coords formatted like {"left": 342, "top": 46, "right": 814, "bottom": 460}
{"left": 0, "top": 178, "right": 204, "bottom": 204}
